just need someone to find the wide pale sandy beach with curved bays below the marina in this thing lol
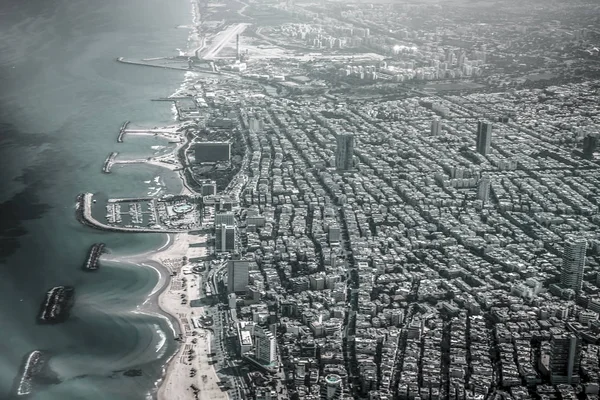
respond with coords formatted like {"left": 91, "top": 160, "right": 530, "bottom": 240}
{"left": 103, "top": 233, "right": 229, "bottom": 400}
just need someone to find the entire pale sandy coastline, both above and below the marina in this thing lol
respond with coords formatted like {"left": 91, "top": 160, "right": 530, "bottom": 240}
{"left": 107, "top": 0, "right": 229, "bottom": 400}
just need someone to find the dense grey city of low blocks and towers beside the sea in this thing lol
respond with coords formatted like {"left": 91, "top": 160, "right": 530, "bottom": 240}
{"left": 82, "top": 0, "right": 600, "bottom": 400}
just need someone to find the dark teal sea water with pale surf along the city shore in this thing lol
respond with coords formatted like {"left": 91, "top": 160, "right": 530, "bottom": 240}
{"left": 0, "top": 0, "right": 191, "bottom": 399}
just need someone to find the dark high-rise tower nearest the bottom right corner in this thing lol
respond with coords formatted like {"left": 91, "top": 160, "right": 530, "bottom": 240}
{"left": 550, "top": 330, "right": 581, "bottom": 385}
